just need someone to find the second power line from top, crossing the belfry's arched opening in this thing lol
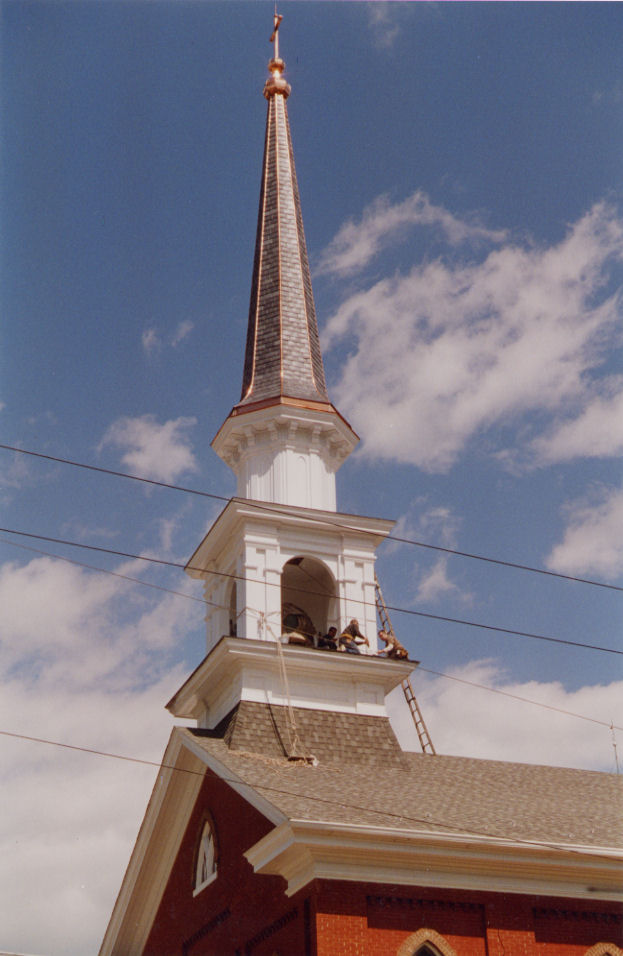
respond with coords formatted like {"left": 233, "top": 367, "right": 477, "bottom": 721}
{"left": 0, "top": 528, "right": 623, "bottom": 656}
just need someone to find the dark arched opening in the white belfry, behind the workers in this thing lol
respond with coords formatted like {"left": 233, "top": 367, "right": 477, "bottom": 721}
{"left": 281, "top": 555, "right": 337, "bottom": 643}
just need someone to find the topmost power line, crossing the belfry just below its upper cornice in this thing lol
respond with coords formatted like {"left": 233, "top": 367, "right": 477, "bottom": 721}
{"left": 0, "top": 444, "right": 623, "bottom": 592}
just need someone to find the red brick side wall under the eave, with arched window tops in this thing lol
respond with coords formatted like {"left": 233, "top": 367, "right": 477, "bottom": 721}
{"left": 314, "top": 880, "right": 623, "bottom": 956}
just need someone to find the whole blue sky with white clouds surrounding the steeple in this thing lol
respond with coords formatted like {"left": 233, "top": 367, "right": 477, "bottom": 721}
{"left": 0, "top": 0, "right": 623, "bottom": 954}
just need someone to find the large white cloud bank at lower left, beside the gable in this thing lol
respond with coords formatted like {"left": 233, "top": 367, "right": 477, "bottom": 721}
{"left": 0, "top": 558, "right": 201, "bottom": 956}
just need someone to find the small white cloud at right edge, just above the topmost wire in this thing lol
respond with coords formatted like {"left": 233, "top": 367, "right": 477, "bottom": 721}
{"left": 547, "top": 487, "right": 623, "bottom": 581}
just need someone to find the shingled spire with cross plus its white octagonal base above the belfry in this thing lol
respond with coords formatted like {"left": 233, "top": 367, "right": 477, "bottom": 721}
{"left": 212, "top": 13, "right": 358, "bottom": 510}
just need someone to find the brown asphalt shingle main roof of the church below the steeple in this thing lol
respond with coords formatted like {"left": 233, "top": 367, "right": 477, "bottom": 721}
{"left": 183, "top": 704, "right": 623, "bottom": 849}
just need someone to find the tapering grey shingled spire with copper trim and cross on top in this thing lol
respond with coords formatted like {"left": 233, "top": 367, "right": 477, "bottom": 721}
{"left": 236, "top": 23, "right": 329, "bottom": 411}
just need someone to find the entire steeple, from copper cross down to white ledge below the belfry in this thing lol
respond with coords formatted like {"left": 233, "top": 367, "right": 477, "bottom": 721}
{"left": 168, "top": 17, "right": 398, "bottom": 728}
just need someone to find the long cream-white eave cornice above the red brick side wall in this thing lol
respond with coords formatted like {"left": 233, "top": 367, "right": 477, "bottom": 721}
{"left": 245, "top": 820, "right": 623, "bottom": 902}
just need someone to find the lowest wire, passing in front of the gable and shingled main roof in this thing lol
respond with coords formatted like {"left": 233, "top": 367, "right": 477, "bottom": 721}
{"left": 0, "top": 730, "right": 616, "bottom": 856}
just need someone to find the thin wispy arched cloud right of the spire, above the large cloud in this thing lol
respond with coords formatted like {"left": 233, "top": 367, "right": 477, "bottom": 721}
{"left": 318, "top": 190, "right": 506, "bottom": 276}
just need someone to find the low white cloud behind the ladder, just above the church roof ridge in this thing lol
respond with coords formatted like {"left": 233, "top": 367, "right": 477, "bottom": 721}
{"left": 388, "top": 661, "right": 623, "bottom": 772}
